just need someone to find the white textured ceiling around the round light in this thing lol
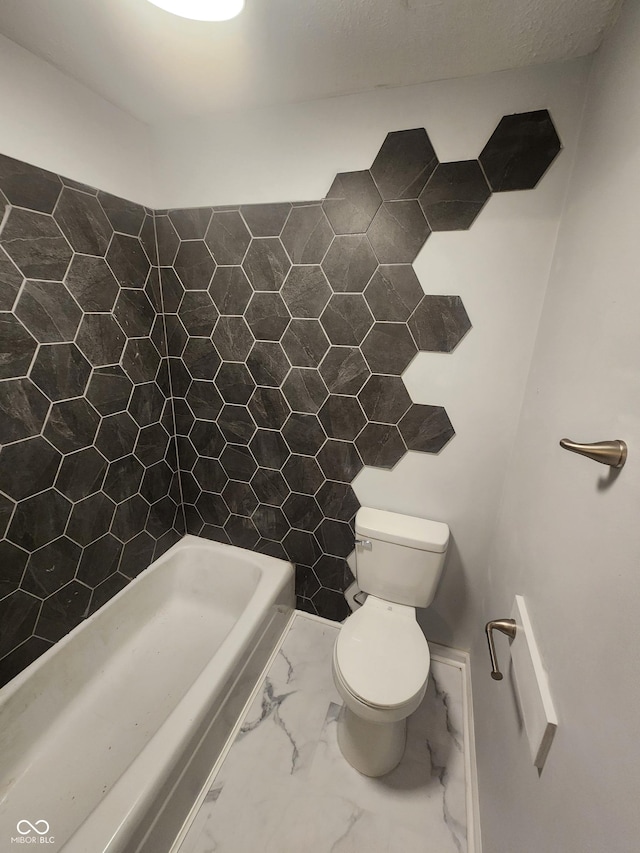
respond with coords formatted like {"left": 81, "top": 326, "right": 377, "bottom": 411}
{"left": 0, "top": 0, "right": 619, "bottom": 123}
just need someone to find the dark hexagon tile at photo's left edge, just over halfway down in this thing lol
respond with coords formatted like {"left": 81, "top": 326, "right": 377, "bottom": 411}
{"left": 0, "top": 435, "right": 62, "bottom": 501}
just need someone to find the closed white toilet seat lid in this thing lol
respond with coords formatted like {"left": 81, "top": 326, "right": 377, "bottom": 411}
{"left": 334, "top": 595, "right": 431, "bottom": 710}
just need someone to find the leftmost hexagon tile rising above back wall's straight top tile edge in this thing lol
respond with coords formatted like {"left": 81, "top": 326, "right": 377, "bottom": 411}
{"left": 322, "top": 171, "right": 382, "bottom": 234}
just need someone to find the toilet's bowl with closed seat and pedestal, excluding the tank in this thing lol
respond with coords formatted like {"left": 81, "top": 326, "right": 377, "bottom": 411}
{"left": 333, "top": 595, "right": 430, "bottom": 776}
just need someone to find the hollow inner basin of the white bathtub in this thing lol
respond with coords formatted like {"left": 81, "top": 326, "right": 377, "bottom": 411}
{"left": 0, "top": 537, "right": 294, "bottom": 840}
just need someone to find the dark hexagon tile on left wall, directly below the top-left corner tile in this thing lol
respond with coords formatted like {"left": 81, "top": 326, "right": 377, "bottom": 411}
{"left": 0, "top": 208, "right": 72, "bottom": 281}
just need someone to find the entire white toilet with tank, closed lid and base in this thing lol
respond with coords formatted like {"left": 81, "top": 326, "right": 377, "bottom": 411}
{"left": 333, "top": 507, "right": 449, "bottom": 776}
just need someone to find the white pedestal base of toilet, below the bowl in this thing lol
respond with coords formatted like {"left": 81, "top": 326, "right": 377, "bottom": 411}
{"left": 338, "top": 705, "right": 407, "bottom": 776}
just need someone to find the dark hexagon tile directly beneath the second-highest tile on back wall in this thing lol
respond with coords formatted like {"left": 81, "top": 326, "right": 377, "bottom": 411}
{"left": 367, "top": 201, "right": 431, "bottom": 264}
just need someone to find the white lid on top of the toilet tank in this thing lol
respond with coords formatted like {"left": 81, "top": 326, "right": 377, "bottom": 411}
{"left": 356, "top": 506, "right": 449, "bottom": 554}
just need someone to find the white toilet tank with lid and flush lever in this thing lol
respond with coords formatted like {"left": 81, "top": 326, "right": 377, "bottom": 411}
{"left": 356, "top": 507, "right": 449, "bottom": 607}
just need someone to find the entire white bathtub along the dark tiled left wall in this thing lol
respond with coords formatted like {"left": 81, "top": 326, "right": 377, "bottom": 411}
{"left": 0, "top": 536, "right": 294, "bottom": 853}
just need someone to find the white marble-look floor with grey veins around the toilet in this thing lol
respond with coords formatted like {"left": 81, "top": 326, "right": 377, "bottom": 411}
{"left": 179, "top": 614, "right": 468, "bottom": 853}
